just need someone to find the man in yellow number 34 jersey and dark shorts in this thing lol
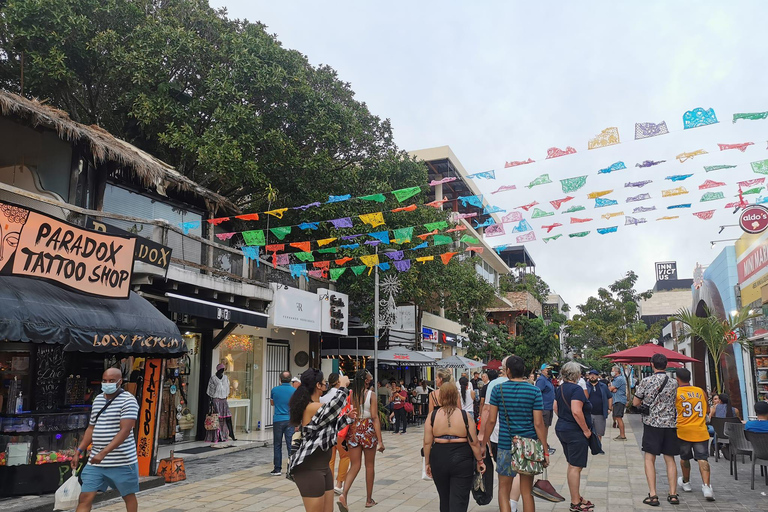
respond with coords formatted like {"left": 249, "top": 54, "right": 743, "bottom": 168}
{"left": 676, "top": 368, "right": 715, "bottom": 501}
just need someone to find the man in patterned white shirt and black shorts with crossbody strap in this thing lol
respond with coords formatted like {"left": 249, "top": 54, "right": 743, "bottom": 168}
{"left": 633, "top": 354, "right": 680, "bottom": 507}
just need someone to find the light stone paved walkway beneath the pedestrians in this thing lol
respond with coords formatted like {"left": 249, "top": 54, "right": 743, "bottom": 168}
{"left": 98, "top": 415, "right": 768, "bottom": 512}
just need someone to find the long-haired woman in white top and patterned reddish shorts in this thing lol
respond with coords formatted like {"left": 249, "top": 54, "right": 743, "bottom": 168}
{"left": 338, "top": 368, "right": 384, "bottom": 512}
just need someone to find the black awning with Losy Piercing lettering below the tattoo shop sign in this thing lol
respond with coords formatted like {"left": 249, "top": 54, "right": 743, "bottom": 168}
{"left": 0, "top": 276, "right": 187, "bottom": 356}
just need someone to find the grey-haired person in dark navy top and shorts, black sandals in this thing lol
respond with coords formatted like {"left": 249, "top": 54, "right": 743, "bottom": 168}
{"left": 554, "top": 361, "right": 594, "bottom": 512}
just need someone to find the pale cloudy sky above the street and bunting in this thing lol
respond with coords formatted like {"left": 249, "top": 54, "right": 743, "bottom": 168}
{"left": 211, "top": 0, "right": 768, "bottom": 307}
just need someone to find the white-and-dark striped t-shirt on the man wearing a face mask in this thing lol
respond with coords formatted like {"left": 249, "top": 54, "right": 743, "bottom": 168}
{"left": 90, "top": 391, "right": 139, "bottom": 467}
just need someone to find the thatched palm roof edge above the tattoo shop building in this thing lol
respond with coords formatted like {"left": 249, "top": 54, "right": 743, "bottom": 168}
{"left": 0, "top": 90, "right": 239, "bottom": 212}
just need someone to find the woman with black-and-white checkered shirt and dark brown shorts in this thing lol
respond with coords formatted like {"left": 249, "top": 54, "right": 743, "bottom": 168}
{"left": 288, "top": 368, "right": 357, "bottom": 512}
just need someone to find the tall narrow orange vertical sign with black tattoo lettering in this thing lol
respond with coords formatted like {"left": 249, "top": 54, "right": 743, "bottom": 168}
{"left": 136, "top": 358, "right": 163, "bottom": 476}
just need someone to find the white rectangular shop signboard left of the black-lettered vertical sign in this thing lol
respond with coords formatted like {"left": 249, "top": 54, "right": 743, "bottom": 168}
{"left": 269, "top": 283, "right": 320, "bottom": 332}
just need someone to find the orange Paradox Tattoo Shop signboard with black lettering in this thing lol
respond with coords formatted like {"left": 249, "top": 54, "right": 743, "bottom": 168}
{"left": 0, "top": 202, "right": 136, "bottom": 299}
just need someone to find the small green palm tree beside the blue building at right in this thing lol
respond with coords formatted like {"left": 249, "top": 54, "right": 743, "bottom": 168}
{"left": 672, "top": 307, "right": 758, "bottom": 393}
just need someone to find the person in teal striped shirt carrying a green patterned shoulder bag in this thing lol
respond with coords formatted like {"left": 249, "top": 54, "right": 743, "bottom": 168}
{"left": 483, "top": 356, "right": 549, "bottom": 512}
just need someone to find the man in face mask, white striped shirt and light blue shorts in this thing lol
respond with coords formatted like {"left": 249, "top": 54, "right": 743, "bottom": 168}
{"left": 72, "top": 368, "right": 139, "bottom": 512}
